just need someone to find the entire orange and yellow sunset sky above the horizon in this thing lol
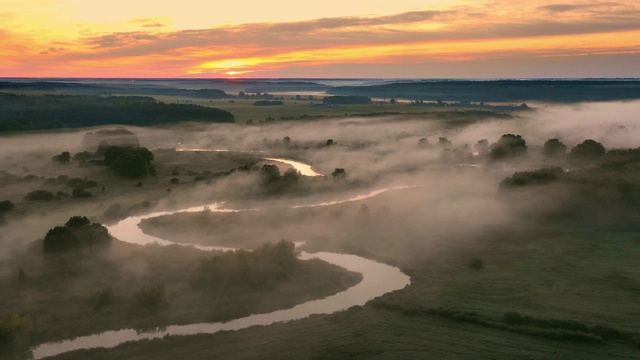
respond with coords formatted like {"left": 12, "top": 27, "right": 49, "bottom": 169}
{"left": 0, "top": 0, "right": 640, "bottom": 79}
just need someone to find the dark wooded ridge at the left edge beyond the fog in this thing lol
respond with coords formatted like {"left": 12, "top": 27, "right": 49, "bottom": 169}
{"left": 0, "top": 93, "right": 234, "bottom": 132}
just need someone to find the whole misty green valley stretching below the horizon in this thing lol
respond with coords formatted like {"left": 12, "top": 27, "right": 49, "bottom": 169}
{"left": 0, "top": 83, "right": 640, "bottom": 360}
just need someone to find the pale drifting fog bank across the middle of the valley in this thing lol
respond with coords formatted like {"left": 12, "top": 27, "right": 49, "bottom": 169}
{"left": 0, "top": 101, "right": 640, "bottom": 254}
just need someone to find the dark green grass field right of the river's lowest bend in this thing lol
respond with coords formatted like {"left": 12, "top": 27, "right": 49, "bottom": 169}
{"left": 67, "top": 186, "right": 640, "bottom": 360}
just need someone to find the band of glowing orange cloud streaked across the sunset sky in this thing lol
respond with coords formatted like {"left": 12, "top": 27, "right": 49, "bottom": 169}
{"left": 0, "top": 0, "right": 640, "bottom": 77}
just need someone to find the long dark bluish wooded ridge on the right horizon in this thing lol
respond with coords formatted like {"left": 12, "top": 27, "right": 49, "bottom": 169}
{"left": 327, "top": 80, "right": 640, "bottom": 103}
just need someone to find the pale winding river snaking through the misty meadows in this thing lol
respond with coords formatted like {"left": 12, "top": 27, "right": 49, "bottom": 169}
{"left": 32, "top": 158, "right": 410, "bottom": 359}
